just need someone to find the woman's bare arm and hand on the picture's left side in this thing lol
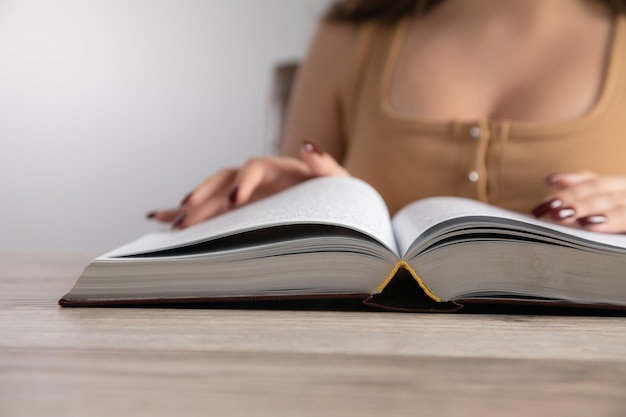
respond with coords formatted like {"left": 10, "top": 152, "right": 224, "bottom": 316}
{"left": 148, "top": 24, "right": 355, "bottom": 229}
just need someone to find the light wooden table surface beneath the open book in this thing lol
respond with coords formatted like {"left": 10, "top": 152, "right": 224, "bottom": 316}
{"left": 0, "top": 251, "right": 626, "bottom": 417}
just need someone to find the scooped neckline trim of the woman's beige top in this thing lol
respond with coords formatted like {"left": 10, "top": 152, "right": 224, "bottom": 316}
{"left": 379, "top": 14, "right": 624, "bottom": 135}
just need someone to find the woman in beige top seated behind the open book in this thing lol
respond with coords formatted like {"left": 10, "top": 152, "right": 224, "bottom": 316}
{"left": 150, "top": 0, "right": 626, "bottom": 233}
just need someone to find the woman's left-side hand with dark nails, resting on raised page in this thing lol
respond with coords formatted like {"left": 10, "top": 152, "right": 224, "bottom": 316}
{"left": 147, "top": 142, "right": 349, "bottom": 229}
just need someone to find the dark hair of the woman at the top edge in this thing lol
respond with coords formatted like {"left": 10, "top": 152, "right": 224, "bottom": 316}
{"left": 324, "top": 0, "right": 626, "bottom": 23}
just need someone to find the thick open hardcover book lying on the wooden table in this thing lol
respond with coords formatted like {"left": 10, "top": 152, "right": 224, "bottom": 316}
{"left": 59, "top": 177, "right": 626, "bottom": 310}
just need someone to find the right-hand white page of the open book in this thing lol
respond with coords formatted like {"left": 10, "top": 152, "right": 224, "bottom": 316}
{"left": 392, "top": 197, "right": 626, "bottom": 255}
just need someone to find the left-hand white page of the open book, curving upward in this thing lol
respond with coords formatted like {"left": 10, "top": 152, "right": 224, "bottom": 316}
{"left": 101, "top": 177, "right": 397, "bottom": 258}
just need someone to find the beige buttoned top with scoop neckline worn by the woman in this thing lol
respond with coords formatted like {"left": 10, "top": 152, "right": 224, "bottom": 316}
{"left": 342, "top": 16, "right": 626, "bottom": 214}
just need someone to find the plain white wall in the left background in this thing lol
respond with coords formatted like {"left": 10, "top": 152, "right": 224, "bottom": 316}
{"left": 0, "top": 0, "right": 329, "bottom": 251}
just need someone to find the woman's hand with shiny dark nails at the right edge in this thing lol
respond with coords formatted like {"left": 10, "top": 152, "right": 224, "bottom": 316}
{"left": 533, "top": 171, "right": 626, "bottom": 233}
